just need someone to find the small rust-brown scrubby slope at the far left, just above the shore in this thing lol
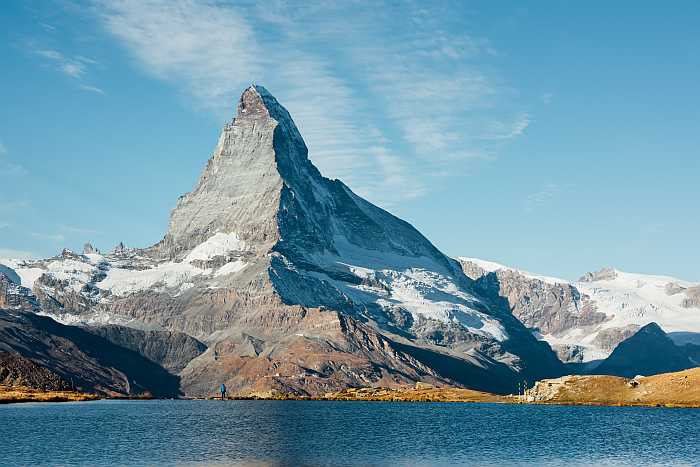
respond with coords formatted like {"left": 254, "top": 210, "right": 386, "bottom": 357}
{"left": 0, "top": 352, "right": 72, "bottom": 391}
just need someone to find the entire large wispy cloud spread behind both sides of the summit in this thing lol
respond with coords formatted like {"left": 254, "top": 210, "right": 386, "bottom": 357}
{"left": 87, "top": 0, "right": 530, "bottom": 205}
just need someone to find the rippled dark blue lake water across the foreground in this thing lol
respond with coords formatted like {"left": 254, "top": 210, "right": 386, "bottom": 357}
{"left": 0, "top": 401, "right": 700, "bottom": 466}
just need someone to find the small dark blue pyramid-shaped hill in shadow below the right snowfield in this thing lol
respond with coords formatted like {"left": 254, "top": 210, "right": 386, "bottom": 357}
{"left": 593, "top": 323, "right": 696, "bottom": 378}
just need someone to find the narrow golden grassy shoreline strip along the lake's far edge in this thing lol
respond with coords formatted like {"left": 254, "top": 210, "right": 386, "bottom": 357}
{"left": 5, "top": 368, "right": 700, "bottom": 408}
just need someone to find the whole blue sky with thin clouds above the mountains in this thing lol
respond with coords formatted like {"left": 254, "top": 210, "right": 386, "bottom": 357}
{"left": 0, "top": 0, "right": 700, "bottom": 281}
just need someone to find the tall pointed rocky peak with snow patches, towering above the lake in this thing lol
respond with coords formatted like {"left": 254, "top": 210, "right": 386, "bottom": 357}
{"left": 4, "top": 86, "right": 563, "bottom": 395}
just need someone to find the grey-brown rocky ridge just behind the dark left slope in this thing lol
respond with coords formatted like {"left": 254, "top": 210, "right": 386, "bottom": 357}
{"left": 87, "top": 324, "right": 207, "bottom": 374}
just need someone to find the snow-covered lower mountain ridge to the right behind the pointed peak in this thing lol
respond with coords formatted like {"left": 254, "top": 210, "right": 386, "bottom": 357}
{"left": 459, "top": 257, "right": 700, "bottom": 365}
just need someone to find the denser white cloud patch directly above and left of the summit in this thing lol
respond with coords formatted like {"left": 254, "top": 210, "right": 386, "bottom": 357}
{"left": 95, "top": 0, "right": 264, "bottom": 111}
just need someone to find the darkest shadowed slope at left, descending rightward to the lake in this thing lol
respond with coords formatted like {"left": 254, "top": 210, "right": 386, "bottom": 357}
{"left": 0, "top": 310, "right": 180, "bottom": 397}
